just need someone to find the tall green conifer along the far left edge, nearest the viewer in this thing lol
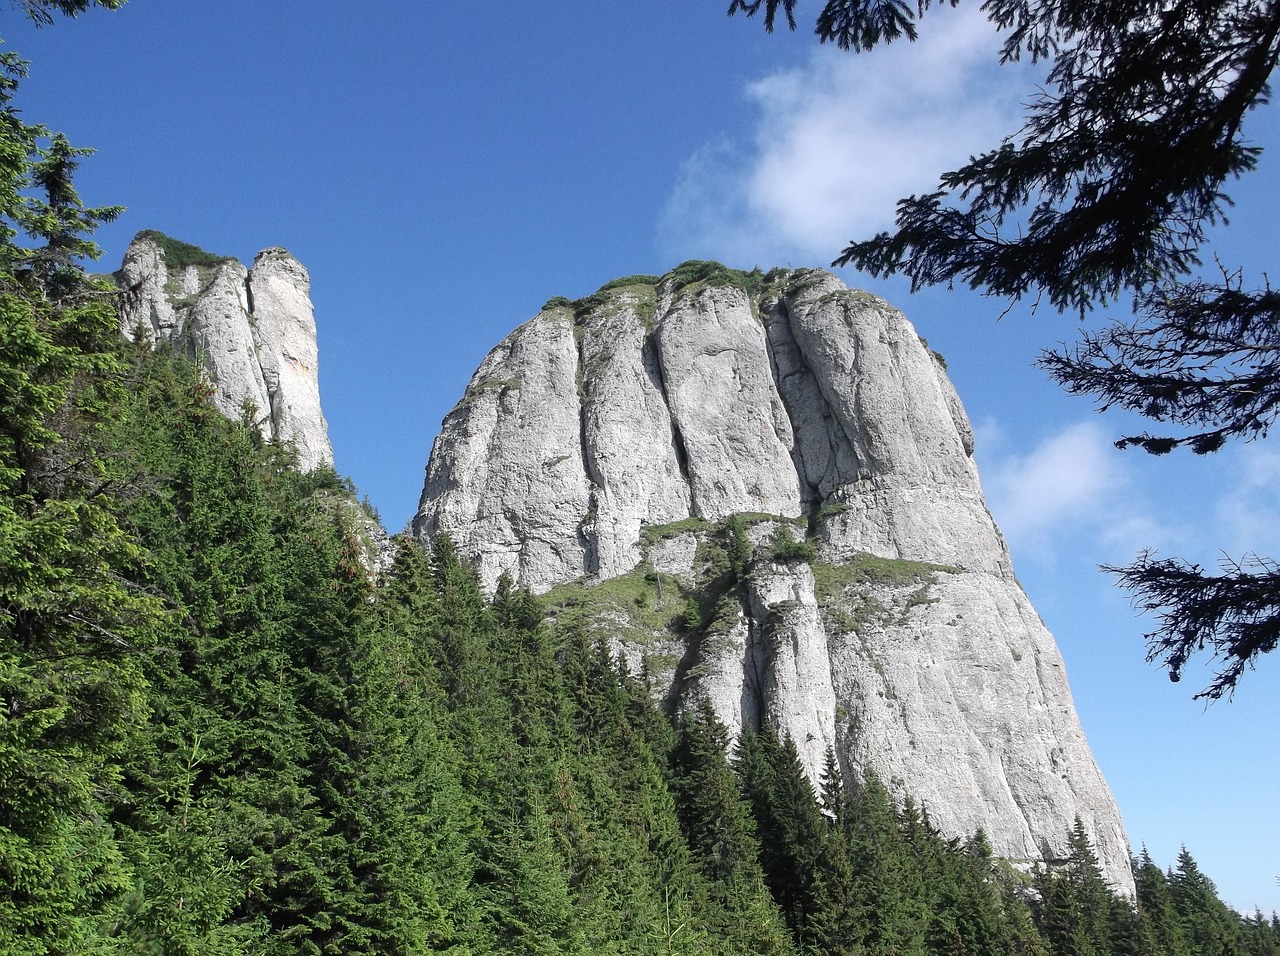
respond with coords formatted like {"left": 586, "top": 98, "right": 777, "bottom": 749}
{"left": 0, "top": 46, "right": 164, "bottom": 953}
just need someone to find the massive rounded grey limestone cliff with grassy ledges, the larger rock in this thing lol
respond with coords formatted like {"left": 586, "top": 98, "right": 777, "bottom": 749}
{"left": 415, "top": 264, "right": 1132, "bottom": 892}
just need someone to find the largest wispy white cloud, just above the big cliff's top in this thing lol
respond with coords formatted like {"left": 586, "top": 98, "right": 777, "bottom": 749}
{"left": 660, "top": 8, "right": 1025, "bottom": 265}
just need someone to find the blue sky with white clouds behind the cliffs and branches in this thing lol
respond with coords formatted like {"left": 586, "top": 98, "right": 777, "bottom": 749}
{"left": 0, "top": 0, "right": 1280, "bottom": 911}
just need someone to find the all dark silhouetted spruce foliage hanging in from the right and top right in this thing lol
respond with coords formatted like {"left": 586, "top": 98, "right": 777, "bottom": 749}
{"left": 728, "top": 0, "right": 1280, "bottom": 699}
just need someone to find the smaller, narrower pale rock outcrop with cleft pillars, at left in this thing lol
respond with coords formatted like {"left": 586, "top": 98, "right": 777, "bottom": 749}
{"left": 115, "top": 233, "right": 333, "bottom": 470}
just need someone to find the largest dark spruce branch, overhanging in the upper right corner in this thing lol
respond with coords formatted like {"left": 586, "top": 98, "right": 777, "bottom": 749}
{"left": 836, "top": 4, "right": 1280, "bottom": 312}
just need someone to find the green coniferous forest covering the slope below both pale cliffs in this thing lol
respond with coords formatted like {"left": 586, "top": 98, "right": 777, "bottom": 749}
{"left": 0, "top": 8, "right": 1280, "bottom": 956}
